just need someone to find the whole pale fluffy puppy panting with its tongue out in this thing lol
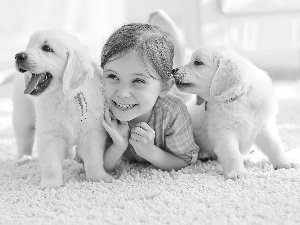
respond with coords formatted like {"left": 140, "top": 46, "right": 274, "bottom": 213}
{"left": 13, "top": 30, "right": 112, "bottom": 189}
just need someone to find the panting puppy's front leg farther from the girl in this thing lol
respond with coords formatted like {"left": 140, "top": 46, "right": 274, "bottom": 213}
{"left": 37, "top": 135, "right": 66, "bottom": 189}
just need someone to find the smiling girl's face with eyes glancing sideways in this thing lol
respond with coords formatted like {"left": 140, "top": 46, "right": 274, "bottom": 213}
{"left": 103, "top": 51, "right": 165, "bottom": 122}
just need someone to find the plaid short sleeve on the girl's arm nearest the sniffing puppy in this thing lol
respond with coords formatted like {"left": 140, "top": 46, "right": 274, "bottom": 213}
{"left": 165, "top": 100, "right": 199, "bottom": 164}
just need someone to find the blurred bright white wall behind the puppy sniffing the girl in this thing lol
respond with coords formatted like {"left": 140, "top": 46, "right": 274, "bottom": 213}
{"left": 125, "top": 0, "right": 300, "bottom": 77}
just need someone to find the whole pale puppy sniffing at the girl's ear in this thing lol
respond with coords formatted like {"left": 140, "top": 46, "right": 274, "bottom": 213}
{"left": 174, "top": 47, "right": 299, "bottom": 179}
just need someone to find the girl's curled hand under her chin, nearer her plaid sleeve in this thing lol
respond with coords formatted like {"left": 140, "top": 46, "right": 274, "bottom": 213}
{"left": 129, "top": 122, "right": 155, "bottom": 159}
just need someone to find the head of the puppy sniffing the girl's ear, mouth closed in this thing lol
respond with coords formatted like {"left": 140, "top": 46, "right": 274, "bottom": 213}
{"left": 174, "top": 47, "right": 246, "bottom": 101}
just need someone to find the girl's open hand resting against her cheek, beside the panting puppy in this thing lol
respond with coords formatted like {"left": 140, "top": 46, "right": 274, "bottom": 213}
{"left": 101, "top": 103, "right": 129, "bottom": 151}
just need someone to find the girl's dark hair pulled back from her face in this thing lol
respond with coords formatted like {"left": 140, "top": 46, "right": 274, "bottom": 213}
{"left": 101, "top": 23, "right": 174, "bottom": 81}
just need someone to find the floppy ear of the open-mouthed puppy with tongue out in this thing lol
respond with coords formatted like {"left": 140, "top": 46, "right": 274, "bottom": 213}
{"left": 63, "top": 49, "right": 94, "bottom": 94}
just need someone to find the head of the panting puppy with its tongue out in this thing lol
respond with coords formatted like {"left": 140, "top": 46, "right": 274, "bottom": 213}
{"left": 15, "top": 30, "right": 93, "bottom": 95}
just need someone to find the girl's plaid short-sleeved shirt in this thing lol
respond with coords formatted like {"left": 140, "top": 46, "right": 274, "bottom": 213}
{"left": 123, "top": 93, "right": 199, "bottom": 164}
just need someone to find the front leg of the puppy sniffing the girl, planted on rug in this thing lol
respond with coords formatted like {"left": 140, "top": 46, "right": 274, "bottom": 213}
{"left": 214, "top": 134, "right": 246, "bottom": 180}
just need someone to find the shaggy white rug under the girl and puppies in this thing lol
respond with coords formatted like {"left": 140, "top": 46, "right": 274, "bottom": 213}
{"left": 0, "top": 82, "right": 300, "bottom": 225}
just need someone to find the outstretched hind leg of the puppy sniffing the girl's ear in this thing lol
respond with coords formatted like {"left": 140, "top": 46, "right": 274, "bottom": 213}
{"left": 255, "top": 120, "right": 300, "bottom": 169}
